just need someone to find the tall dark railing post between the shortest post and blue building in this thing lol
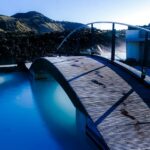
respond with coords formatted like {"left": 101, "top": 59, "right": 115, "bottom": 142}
{"left": 111, "top": 23, "right": 116, "bottom": 62}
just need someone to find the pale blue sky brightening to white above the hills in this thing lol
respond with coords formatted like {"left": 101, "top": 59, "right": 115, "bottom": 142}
{"left": 0, "top": 0, "right": 150, "bottom": 25}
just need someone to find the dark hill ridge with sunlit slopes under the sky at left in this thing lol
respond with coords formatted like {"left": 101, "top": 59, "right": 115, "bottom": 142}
{"left": 0, "top": 11, "right": 83, "bottom": 33}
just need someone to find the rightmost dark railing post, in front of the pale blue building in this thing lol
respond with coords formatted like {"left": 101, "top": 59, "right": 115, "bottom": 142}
{"left": 141, "top": 32, "right": 148, "bottom": 80}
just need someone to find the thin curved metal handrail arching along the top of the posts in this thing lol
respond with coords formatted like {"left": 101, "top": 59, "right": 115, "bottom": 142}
{"left": 57, "top": 21, "right": 150, "bottom": 51}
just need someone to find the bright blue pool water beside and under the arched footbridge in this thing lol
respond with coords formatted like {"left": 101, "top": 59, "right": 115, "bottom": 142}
{"left": 0, "top": 73, "right": 94, "bottom": 150}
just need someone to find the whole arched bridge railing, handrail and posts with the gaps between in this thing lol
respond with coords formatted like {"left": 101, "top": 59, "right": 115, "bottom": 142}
{"left": 57, "top": 21, "right": 150, "bottom": 79}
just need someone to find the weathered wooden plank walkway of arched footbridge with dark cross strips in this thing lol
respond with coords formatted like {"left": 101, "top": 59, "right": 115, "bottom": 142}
{"left": 35, "top": 56, "right": 150, "bottom": 150}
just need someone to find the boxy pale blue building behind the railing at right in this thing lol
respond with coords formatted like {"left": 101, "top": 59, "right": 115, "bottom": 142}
{"left": 126, "top": 28, "right": 150, "bottom": 66}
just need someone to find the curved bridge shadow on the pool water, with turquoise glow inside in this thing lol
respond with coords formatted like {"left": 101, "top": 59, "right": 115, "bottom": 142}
{"left": 31, "top": 76, "right": 96, "bottom": 150}
